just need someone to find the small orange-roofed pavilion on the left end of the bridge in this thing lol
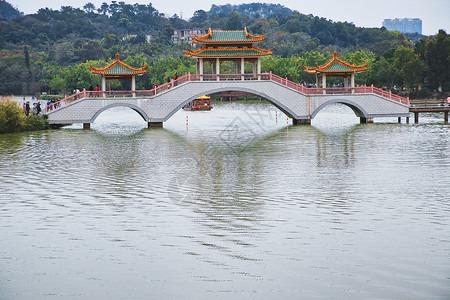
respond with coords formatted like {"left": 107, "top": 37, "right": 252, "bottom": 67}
{"left": 90, "top": 54, "right": 148, "bottom": 97}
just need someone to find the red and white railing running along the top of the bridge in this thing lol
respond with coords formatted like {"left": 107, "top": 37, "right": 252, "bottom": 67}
{"left": 46, "top": 72, "right": 409, "bottom": 112}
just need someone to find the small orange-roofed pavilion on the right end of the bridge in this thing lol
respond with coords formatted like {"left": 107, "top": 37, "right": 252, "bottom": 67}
{"left": 303, "top": 51, "right": 369, "bottom": 93}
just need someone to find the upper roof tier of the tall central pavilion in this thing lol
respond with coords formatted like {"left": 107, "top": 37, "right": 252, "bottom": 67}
{"left": 191, "top": 28, "right": 266, "bottom": 44}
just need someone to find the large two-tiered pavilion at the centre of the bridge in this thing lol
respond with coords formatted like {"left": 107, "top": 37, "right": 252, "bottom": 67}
{"left": 184, "top": 28, "right": 273, "bottom": 80}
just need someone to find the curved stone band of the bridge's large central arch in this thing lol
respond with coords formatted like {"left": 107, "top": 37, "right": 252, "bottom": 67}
{"left": 164, "top": 87, "right": 295, "bottom": 121}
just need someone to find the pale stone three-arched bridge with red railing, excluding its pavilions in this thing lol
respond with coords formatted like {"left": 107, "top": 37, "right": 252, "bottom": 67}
{"left": 47, "top": 73, "right": 409, "bottom": 128}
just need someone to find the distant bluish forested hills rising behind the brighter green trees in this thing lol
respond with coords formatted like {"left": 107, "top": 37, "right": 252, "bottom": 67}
{"left": 0, "top": 0, "right": 409, "bottom": 55}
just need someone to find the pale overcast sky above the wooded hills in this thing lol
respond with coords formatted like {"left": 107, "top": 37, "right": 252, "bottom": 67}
{"left": 7, "top": 0, "right": 450, "bottom": 35}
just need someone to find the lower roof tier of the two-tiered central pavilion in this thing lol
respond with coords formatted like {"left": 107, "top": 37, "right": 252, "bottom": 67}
{"left": 184, "top": 46, "right": 273, "bottom": 58}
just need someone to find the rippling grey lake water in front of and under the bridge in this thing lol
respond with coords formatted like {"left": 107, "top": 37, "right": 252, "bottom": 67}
{"left": 0, "top": 102, "right": 450, "bottom": 300}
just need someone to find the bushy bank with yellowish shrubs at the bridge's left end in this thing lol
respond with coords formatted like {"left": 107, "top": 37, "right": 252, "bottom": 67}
{"left": 0, "top": 97, "right": 50, "bottom": 133}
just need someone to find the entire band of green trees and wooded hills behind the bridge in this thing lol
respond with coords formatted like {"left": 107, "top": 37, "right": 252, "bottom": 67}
{"left": 0, "top": 1, "right": 450, "bottom": 98}
